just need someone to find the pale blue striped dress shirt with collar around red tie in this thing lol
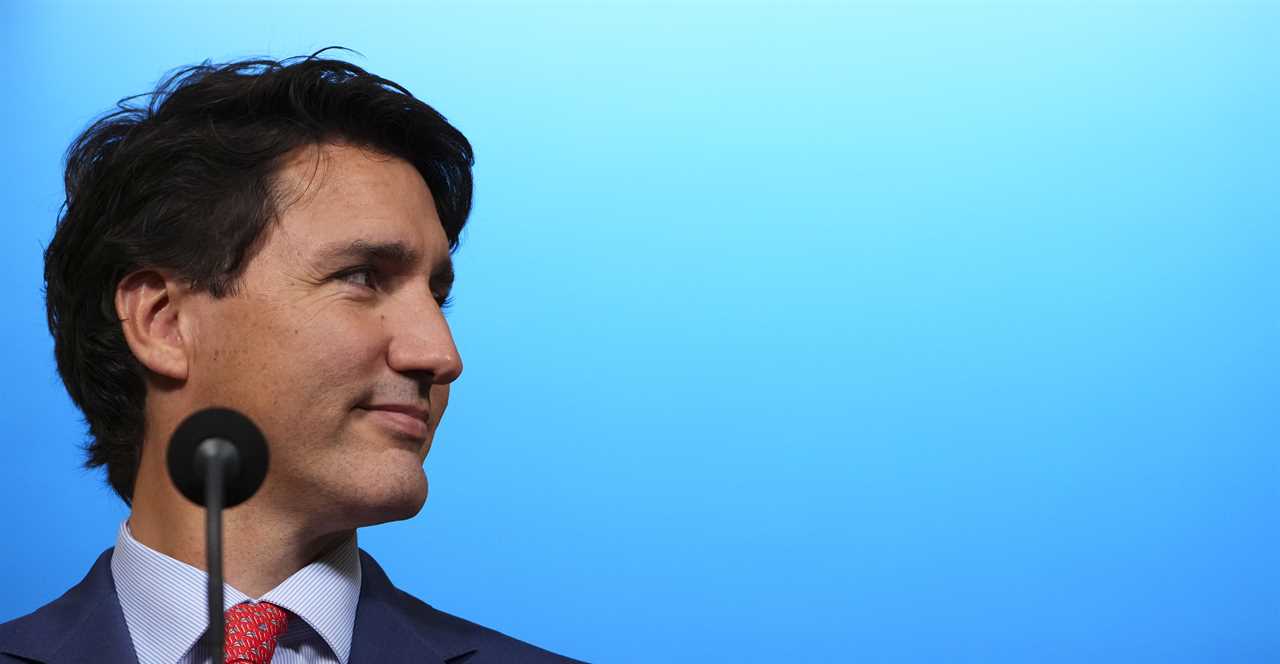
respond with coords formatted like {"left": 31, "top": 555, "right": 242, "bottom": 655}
{"left": 111, "top": 521, "right": 360, "bottom": 664}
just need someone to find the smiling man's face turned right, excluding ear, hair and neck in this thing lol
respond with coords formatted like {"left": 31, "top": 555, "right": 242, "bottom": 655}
{"left": 186, "top": 146, "right": 462, "bottom": 530}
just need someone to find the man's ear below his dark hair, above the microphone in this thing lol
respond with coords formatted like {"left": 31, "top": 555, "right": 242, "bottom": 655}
{"left": 115, "top": 270, "right": 189, "bottom": 381}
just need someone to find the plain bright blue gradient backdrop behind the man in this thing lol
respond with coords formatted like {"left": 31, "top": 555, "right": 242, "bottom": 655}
{"left": 0, "top": 3, "right": 1280, "bottom": 663}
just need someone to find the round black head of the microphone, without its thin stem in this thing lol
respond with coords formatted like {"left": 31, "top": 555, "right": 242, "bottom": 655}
{"left": 168, "top": 408, "right": 269, "bottom": 507}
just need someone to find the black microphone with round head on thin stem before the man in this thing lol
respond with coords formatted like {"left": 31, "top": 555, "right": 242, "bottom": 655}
{"left": 166, "top": 408, "right": 269, "bottom": 663}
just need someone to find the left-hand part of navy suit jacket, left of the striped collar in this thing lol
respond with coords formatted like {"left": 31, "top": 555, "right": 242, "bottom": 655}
{"left": 0, "top": 549, "right": 138, "bottom": 664}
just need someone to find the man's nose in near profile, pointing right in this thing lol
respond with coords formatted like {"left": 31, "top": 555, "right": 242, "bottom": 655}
{"left": 385, "top": 294, "right": 462, "bottom": 385}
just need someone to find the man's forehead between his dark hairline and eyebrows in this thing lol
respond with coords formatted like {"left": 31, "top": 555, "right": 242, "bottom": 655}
{"left": 275, "top": 143, "right": 448, "bottom": 262}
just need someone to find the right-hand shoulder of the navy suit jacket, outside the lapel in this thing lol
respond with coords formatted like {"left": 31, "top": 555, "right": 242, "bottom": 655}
{"left": 357, "top": 551, "right": 580, "bottom": 664}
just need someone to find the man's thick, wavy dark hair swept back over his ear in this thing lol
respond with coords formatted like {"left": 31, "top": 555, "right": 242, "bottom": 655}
{"left": 45, "top": 49, "right": 474, "bottom": 503}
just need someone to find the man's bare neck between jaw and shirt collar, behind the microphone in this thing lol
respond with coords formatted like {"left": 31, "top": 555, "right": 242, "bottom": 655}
{"left": 129, "top": 437, "right": 355, "bottom": 597}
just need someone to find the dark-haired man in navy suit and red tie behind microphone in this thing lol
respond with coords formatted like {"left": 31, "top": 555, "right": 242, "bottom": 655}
{"left": 0, "top": 56, "right": 583, "bottom": 664}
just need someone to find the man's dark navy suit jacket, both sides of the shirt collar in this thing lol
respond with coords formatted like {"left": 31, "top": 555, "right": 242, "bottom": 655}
{"left": 0, "top": 549, "right": 576, "bottom": 664}
